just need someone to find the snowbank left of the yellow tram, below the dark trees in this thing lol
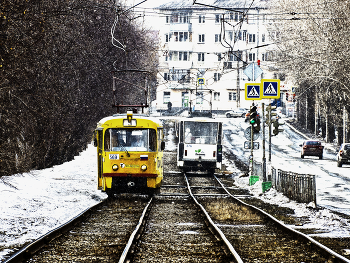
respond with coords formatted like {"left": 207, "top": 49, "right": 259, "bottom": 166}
{"left": 0, "top": 145, "right": 107, "bottom": 261}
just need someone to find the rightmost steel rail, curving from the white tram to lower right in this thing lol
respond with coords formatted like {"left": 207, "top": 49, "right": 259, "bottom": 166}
{"left": 214, "top": 175, "right": 350, "bottom": 263}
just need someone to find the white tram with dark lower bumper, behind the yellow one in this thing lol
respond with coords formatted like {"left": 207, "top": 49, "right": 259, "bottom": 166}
{"left": 177, "top": 117, "right": 223, "bottom": 173}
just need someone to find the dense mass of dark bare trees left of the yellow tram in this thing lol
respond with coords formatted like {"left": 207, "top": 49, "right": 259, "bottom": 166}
{"left": 0, "top": 0, "right": 155, "bottom": 176}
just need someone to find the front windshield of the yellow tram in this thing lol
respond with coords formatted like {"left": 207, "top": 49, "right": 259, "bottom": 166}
{"left": 105, "top": 128, "right": 157, "bottom": 152}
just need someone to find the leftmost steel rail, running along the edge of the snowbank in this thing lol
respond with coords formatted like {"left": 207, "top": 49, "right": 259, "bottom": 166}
{"left": 3, "top": 199, "right": 107, "bottom": 263}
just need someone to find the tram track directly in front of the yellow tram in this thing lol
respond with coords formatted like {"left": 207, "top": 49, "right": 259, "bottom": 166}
{"left": 5, "top": 196, "right": 149, "bottom": 263}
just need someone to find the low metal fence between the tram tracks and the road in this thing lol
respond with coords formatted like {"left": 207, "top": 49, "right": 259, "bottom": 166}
{"left": 271, "top": 167, "right": 316, "bottom": 205}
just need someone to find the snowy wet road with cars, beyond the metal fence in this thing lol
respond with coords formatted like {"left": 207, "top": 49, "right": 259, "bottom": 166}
{"left": 221, "top": 118, "right": 350, "bottom": 215}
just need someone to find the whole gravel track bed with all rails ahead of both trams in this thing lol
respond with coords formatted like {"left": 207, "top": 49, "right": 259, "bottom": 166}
{"left": 6, "top": 173, "right": 350, "bottom": 263}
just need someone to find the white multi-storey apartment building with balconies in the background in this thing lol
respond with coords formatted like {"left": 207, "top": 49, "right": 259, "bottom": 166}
{"left": 154, "top": 0, "right": 283, "bottom": 112}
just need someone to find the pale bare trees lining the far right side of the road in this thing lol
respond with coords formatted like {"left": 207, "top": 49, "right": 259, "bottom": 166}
{"left": 270, "top": 0, "right": 350, "bottom": 142}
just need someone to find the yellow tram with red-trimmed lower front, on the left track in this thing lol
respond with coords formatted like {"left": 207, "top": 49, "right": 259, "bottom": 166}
{"left": 94, "top": 111, "right": 165, "bottom": 196}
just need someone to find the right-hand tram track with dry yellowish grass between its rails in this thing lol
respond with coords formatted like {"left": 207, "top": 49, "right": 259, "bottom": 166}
{"left": 189, "top": 174, "right": 350, "bottom": 262}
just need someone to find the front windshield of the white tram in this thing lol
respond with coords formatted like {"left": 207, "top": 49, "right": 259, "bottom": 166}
{"left": 184, "top": 121, "right": 218, "bottom": 144}
